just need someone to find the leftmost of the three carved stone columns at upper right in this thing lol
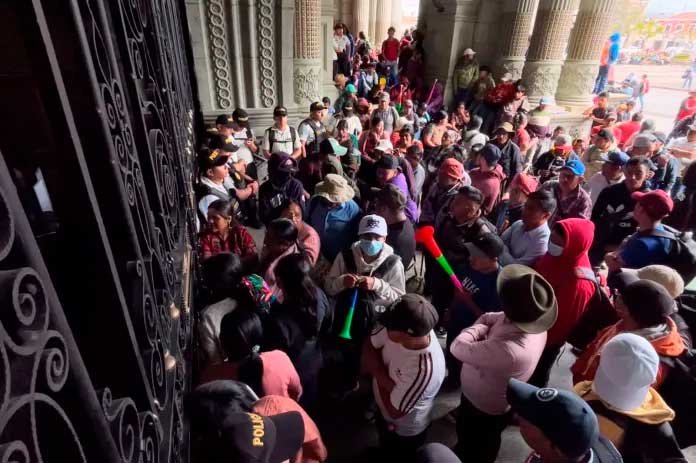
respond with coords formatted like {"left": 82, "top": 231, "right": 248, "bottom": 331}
{"left": 498, "top": 0, "right": 539, "bottom": 79}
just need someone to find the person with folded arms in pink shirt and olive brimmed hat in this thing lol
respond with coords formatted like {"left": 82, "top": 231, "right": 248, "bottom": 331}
{"left": 450, "top": 264, "right": 558, "bottom": 463}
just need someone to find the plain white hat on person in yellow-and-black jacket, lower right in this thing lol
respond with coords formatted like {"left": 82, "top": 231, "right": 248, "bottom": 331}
{"left": 592, "top": 333, "right": 660, "bottom": 412}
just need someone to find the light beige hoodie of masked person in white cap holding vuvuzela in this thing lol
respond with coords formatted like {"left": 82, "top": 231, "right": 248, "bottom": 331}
{"left": 324, "top": 241, "right": 406, "bottom": 307}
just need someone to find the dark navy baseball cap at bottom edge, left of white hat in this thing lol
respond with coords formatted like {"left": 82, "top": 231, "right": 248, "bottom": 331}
{"left": 507, "top": 378, "right": 599, "bottom": 458}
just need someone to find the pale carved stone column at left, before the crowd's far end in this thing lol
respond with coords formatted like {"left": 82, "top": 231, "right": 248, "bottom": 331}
{"left": 293, "top": 0, "right": 321, "bottom": 106}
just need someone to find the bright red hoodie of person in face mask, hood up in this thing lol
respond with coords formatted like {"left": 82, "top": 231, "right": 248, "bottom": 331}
{"left": 534, "top": 218, "right": 595, "bottom": 346}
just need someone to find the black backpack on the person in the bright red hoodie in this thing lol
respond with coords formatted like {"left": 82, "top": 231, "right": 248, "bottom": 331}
{"left": 568, "top": 267, "right": 619, "bottom": 350}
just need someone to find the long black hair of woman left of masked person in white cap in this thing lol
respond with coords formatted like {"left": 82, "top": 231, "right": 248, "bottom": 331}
{"left": 275, "top": 254, "right": 319, "bottom": 338}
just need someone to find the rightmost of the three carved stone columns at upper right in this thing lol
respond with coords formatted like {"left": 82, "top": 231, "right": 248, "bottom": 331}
{"left": 556, "top": 0, "right": 619, "bottom": 107}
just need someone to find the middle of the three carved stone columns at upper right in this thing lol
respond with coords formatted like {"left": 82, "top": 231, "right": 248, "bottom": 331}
{"left": 522, "top": 0, "right": 580, "bottom": 101}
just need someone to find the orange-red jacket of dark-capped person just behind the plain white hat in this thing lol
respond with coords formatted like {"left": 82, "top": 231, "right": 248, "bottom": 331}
{"left": 570, "top": 318, "right": 686, "bottom": 388}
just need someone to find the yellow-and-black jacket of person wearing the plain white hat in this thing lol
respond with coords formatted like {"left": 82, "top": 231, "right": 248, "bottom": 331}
{"left": 574, "top": 381, "right": 687, "bottom": 463}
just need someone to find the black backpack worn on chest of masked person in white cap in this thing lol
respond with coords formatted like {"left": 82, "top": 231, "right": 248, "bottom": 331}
{"left": 331, "top": 248, "right": 401, "bottom": 346}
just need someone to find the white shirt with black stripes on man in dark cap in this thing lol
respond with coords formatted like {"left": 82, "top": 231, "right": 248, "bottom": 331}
{"left": 371, "top": 328, "right": 445, "bottom": 436}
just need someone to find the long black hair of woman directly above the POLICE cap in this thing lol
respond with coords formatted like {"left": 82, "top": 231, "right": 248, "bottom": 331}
{"left": 220, "top": 307, "right": 265, "bottom": 397}
